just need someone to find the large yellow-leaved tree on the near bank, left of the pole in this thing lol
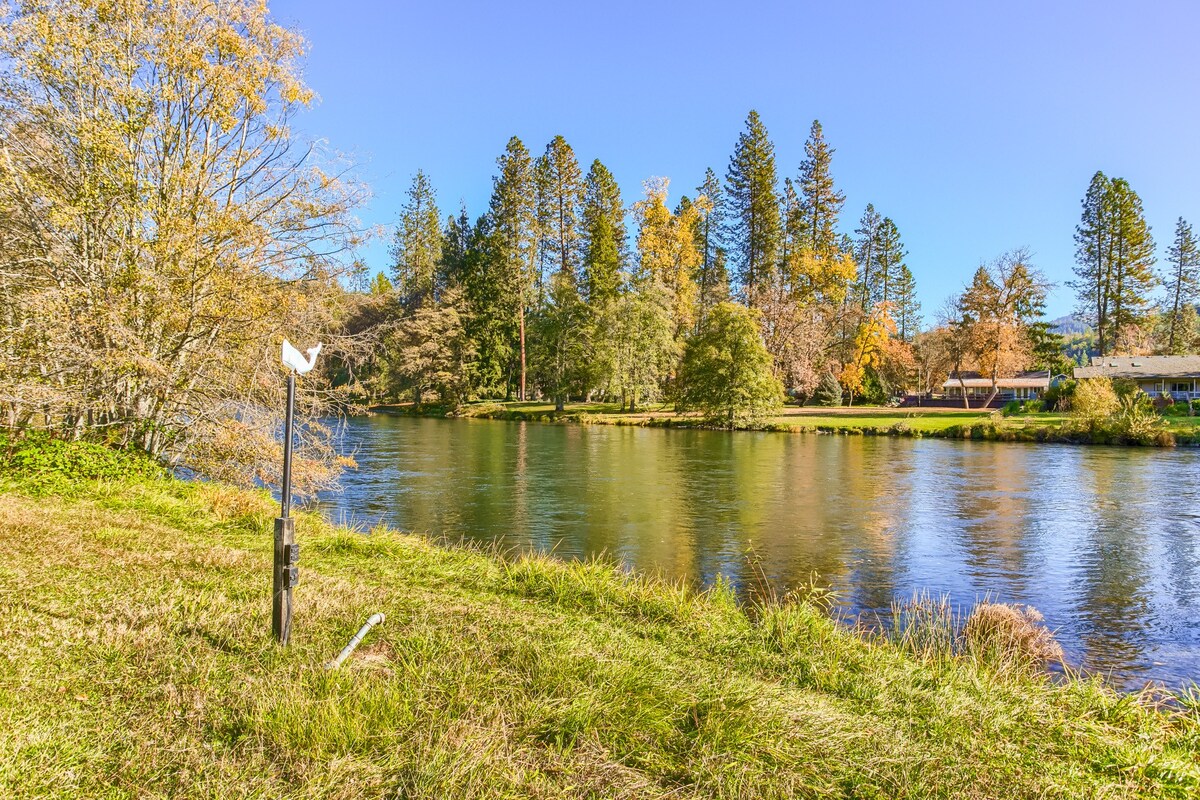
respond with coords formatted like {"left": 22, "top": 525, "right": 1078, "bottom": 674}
{"left": 0, "top": 0, "right": 364, "bottom": 489}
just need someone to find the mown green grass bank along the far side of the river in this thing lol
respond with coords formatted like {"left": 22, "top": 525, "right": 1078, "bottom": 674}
{"left": 373, "top": 402, "right": 1200, "bottom": 446}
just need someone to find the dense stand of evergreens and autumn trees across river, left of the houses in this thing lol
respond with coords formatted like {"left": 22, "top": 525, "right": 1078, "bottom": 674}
{"left": 342, "top": 112, "right": 922, "bottom": 417}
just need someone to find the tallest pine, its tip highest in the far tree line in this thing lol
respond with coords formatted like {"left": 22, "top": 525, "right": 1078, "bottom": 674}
{"left": 725, "top": 110, "right": 781, "bottom": 305}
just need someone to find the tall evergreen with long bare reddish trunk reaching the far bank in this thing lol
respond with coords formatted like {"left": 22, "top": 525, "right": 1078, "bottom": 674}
{"left": 487, "top": 137, "right": 538, "bottom": 399}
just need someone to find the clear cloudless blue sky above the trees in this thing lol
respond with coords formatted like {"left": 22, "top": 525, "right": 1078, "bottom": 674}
{"left": 270, "top": 0, "right": 1200, "bottom": 318}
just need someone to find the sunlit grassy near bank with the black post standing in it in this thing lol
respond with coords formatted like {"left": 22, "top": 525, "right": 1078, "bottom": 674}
{"left": 0, "top": 460, "right": 1200, "bottom": 798}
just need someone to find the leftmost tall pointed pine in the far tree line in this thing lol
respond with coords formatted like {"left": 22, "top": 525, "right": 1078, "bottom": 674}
{"left": 391, "top": 169, "right": 442, "bottom": 302}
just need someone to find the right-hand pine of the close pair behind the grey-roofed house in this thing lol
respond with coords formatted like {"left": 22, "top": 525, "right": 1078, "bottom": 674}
{"left": 1110, "top": 178, "right": 1158, "bottom": 345}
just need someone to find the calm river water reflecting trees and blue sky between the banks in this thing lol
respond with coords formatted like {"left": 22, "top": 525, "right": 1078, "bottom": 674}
{"left": 322, "top": 415, "right": 1200, "bottom": 687}
